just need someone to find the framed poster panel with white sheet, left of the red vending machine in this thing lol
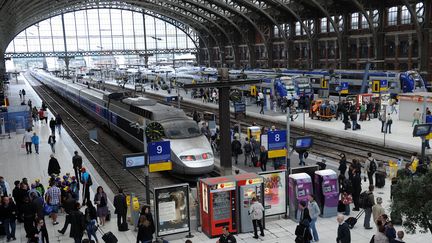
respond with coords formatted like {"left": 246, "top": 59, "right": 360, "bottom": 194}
{"left": 154, "top": 184, "right": 190, "bottom": 236}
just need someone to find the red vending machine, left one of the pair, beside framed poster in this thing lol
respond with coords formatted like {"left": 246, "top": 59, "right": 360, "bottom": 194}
{"left": 199, "top": 177, "right": 237, "bottom": 238}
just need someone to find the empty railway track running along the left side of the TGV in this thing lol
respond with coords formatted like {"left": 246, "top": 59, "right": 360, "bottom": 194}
{"left": 24, "top": 74, "right": 181, "bottom": 203}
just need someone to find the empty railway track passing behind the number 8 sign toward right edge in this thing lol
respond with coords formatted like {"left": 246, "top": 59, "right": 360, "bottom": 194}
{"left": 106, "top": 84, "right": 413, "bottom": 165}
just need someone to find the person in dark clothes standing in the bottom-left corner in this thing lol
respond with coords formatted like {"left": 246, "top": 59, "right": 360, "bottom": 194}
{"left": 0, "top": 196, "right": 17, "bottom": 242}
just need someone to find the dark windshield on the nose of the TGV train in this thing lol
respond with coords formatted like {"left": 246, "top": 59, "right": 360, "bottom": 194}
{"left": 162, "top": 120, "right": 201, "bottom": 139}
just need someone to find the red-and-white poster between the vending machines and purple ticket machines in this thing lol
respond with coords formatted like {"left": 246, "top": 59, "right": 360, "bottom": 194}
{"left": 260, "top": 170, "right": 286, "bottom": 216}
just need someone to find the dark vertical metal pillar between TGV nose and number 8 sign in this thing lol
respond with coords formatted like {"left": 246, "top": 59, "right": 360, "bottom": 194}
{"left": 219, "top": 87, "right": 232, "bottom": 175}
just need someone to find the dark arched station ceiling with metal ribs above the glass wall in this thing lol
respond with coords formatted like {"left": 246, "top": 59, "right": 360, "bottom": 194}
{"left": 0, "top": 0, "right": 418, "bottom": 51}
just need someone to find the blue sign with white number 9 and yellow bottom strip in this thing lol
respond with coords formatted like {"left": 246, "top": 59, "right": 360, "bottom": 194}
{"left": 147, "top": 141, "right": 172, "bottom": 172}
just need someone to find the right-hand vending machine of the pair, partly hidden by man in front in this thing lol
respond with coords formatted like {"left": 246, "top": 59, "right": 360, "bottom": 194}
{"left": 234, "top": 173, "right": 264, "bottom": 233}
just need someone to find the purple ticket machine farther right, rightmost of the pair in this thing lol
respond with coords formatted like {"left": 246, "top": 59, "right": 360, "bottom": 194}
{"left": 315, "top": 170, "right": 339, "bottom": 218}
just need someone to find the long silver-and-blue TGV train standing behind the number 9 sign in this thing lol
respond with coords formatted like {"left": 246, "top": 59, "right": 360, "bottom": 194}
{"left": 30, "top": 70, "right": 214, "bottom": 175}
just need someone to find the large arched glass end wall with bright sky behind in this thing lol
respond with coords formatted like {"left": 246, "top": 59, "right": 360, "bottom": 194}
{"left": 6, "top": 9, "right": 196, "bottom": 53}
